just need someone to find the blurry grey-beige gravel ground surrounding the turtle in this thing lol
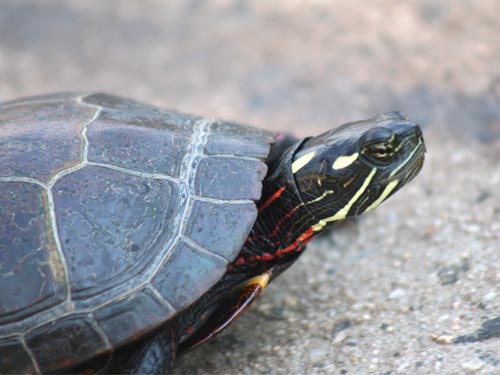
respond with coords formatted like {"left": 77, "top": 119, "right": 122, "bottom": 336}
{"left": 0, "top": 0, "right": 500, "bottom": 375}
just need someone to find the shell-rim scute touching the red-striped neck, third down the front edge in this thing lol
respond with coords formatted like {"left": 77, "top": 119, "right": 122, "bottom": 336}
{"left": 184, "top": 201, "right": 257, "bottom": 262}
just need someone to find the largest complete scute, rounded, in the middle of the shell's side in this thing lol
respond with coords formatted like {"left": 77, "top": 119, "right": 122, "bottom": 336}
{"left": 53, "top": 166, "right": 179, "bottom": 299}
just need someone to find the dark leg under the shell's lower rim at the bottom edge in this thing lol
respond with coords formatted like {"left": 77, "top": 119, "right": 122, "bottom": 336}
{"left": 104, "top": 323, "right": 179, "bottom": 374}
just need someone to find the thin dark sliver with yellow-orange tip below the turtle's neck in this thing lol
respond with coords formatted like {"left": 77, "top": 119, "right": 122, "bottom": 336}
{"left": 178, "top": 270, "right": 271, "bottom": 354}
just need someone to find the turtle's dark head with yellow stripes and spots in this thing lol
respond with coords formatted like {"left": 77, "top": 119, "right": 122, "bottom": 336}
{"left": 292, "top": 112, "right": 425, "bottom": 231}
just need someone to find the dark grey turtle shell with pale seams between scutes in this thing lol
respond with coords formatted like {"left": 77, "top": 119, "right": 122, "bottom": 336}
{"left": 0, "top": 94, "right": 273, "bottom": 373}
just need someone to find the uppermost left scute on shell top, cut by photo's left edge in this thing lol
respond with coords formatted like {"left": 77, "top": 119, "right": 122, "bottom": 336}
{"left": 0, "top": 101, "right": 95, "bottom": 183}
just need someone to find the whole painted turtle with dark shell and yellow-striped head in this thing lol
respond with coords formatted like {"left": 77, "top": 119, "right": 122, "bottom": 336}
{"left": 0, "top": 94, "right": 425, "bottom": 373}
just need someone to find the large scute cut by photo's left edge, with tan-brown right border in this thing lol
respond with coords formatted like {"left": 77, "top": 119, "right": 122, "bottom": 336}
{"left": 0, "top": 181, "right": 67, "bottom": 326}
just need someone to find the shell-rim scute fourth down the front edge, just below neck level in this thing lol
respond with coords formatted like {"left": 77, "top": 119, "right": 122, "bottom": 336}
{"left": 153, "top": 241, "right": 227, "bottom": 311}
